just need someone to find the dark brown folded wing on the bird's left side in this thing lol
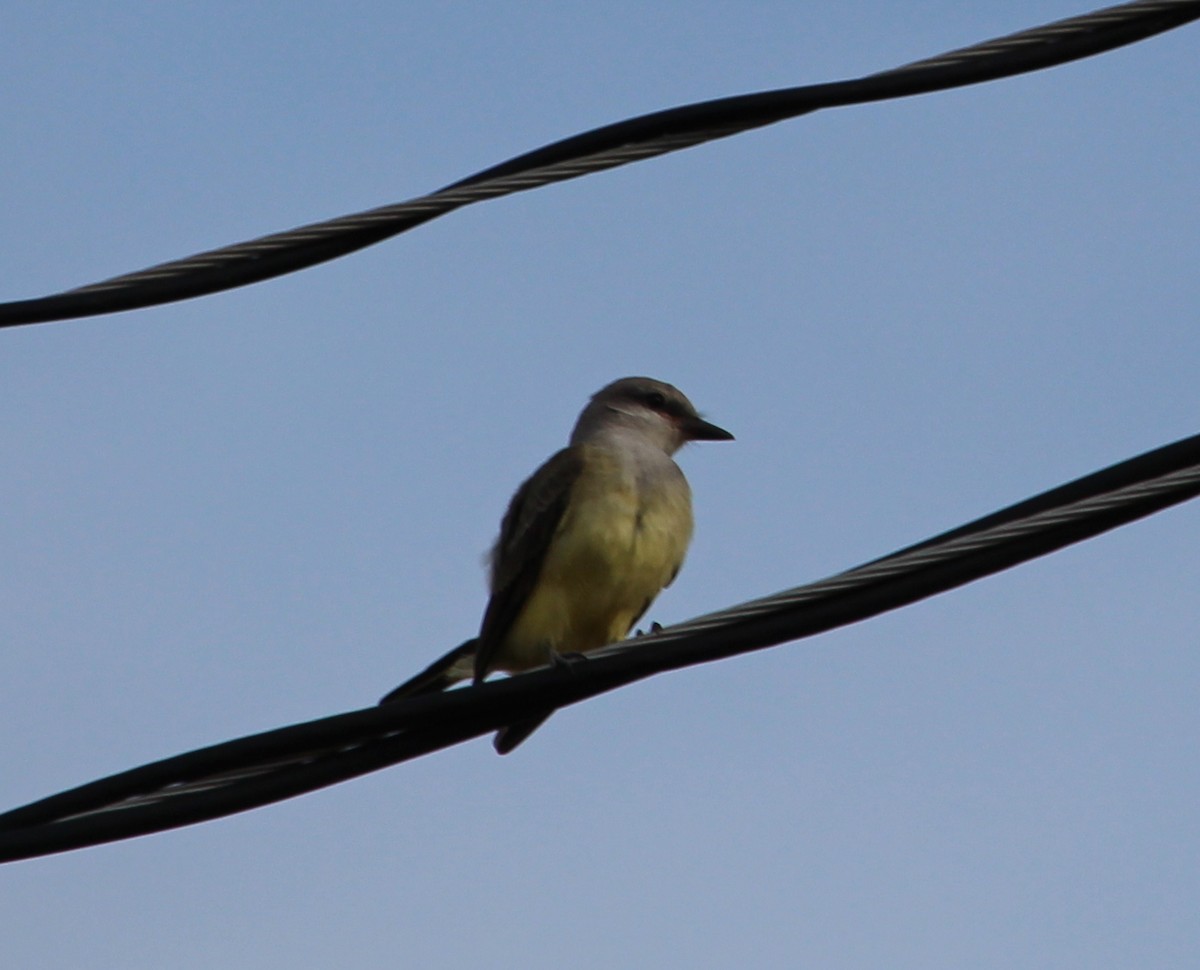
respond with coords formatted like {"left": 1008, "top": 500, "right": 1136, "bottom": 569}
{"left": 475, "top": 448, "right": 583, "bottom": 683}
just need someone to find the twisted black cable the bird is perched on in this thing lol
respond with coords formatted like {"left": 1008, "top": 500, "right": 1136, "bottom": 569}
{"left": 0, "top": 424, "right": 1200, "bottom": 862}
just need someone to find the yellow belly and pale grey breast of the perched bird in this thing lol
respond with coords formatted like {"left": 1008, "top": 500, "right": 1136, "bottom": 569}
{"left": 496, "top": 451, "right": 692, "bottom": 672}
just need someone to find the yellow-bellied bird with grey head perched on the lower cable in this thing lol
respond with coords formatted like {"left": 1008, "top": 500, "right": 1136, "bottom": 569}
{"left": 380, "top": 377, "right": 733, "bottom": 754}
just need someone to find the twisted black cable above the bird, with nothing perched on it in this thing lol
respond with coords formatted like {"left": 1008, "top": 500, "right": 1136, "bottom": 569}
{"left": 0, "top": 0, "right": 1200, "bottom": 327}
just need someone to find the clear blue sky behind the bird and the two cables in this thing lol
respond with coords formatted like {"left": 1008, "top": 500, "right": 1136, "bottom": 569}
{"left": 0, "top": 0, "right": 1200, "bottom": 970}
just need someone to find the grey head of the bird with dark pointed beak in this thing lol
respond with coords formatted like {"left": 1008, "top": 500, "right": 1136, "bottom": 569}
{"left": 571, "top": 377, "right": 733, "bottom": 455}
